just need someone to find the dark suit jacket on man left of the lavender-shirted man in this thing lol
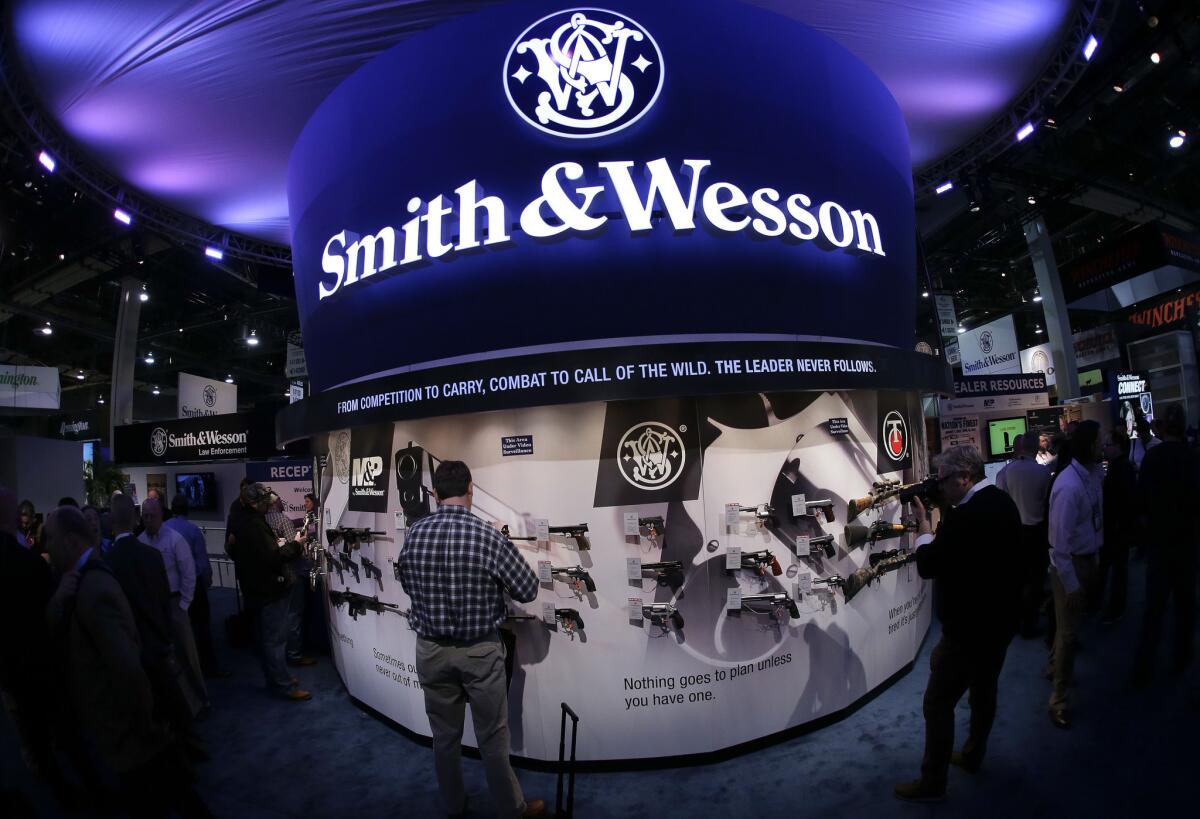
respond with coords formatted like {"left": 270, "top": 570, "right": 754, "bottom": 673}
{"left": 104, "top": 534, "right": 174, "bottom": 668}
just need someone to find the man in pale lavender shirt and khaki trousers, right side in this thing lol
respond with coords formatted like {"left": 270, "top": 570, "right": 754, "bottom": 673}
{"left": 1050, "top": 420, "right": 1104, "bottom": 728}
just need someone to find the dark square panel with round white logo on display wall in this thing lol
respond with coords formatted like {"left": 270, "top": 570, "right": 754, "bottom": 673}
{"left": 594, "top": 399, "right": 701, "bottom": 507}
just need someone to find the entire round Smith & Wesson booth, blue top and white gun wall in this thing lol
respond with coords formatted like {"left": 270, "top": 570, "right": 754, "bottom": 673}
{"left": 276, "top": 0, "right": 950, "bottom": 763}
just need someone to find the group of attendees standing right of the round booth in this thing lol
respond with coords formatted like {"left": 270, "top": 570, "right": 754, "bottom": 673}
{"left": 895, "top": 405, "right": 1200, "bottom": 801}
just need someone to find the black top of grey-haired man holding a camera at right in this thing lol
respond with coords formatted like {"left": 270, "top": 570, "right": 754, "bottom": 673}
{"left": 917, "top": 486, "right": 1021, "bottom": 645}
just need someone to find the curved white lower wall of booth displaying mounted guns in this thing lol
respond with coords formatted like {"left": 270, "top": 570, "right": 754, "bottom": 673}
{"left": 314, "top": 391, "right": 932, "bottom": 760}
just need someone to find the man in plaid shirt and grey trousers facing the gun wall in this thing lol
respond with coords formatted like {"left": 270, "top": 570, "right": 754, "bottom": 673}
{"left": 400, "top": 461, "right": 546, "bottom": 817}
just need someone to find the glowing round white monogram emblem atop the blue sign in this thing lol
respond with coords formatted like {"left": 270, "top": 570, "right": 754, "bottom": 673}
{"left": 504, "top": 8, "right": 664, "bottom": 139}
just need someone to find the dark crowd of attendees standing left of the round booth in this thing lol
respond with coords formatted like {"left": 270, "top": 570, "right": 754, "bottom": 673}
{"left": 0, "top": 482, "right": 317, "bottom": 817}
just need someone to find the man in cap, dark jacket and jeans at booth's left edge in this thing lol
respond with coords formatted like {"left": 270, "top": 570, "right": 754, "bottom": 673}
{"left": 229, "top": 484, "right": 312, "bottom": 701}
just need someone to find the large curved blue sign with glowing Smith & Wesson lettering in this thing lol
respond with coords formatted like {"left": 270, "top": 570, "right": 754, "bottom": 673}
{"left": 288, "top": 0, "right": 921, "bottom": 398}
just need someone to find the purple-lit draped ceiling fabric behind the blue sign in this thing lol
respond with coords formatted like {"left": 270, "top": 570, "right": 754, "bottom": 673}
{"left": 11, "top": 0, "right": 1073, "bottom": 244}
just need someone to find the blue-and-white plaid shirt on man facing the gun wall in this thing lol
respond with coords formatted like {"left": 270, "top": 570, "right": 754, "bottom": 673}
{"left": 400, "top": 506, "right": 538, "bottom": 640}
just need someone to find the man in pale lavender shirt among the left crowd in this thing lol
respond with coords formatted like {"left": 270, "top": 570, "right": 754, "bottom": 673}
{"left": 138, "top": 498, "right": 210, "bottom": 716}
